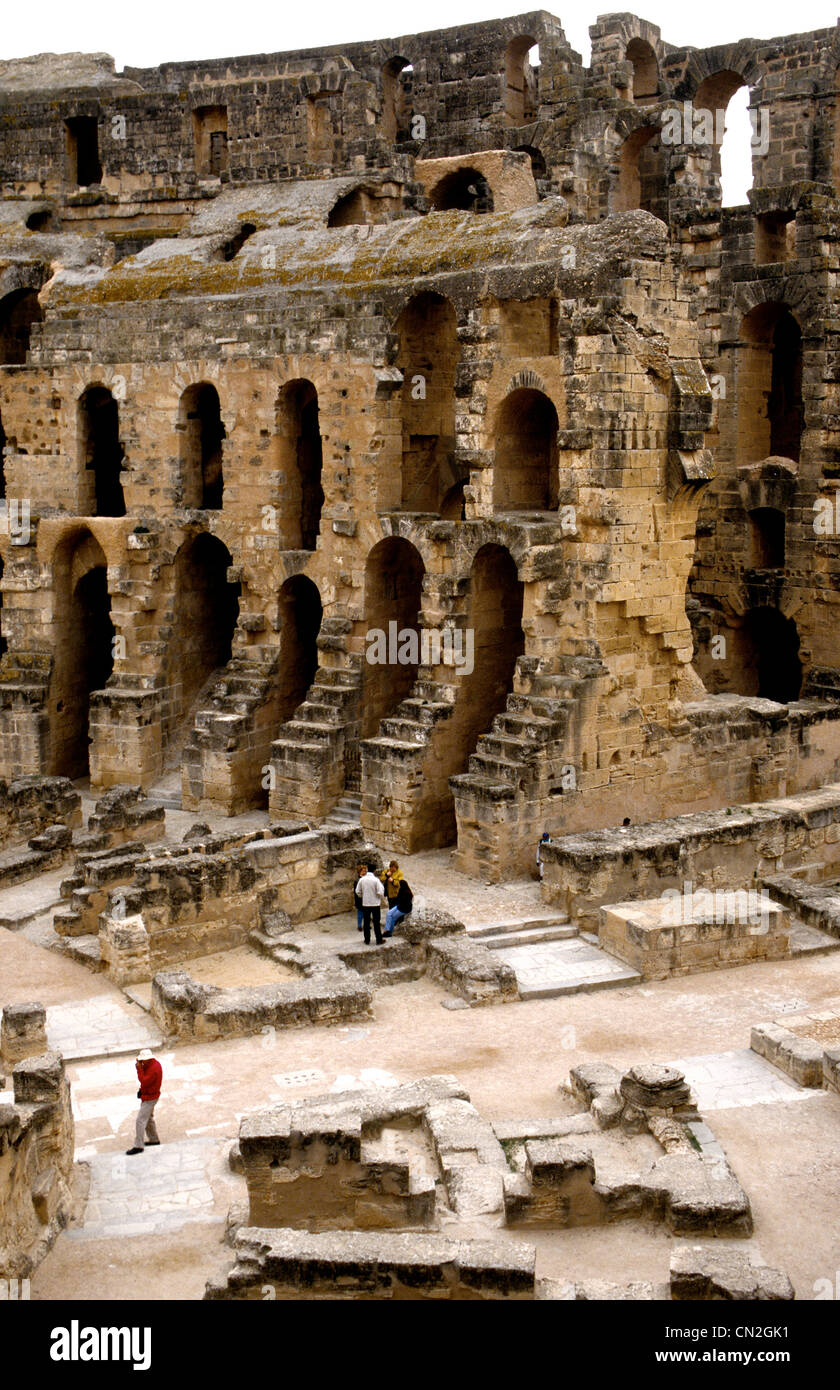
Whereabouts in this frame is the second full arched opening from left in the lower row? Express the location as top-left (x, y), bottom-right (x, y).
top-left (164, 532), bottom-right (241, 737)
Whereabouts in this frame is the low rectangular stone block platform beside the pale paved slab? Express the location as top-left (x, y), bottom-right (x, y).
top-left (598, 891), bottom-right (790, 980)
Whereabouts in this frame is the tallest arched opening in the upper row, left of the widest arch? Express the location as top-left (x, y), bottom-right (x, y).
top-left (396, 293), bottom-right (460, 513)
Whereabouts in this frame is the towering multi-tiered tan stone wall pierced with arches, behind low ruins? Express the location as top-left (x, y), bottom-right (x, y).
top-left (0, 11), bottom-right (840, 878)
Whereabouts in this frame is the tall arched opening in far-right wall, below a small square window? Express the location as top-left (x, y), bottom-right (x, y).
top-left (737, 303), bottom-right (802, 463)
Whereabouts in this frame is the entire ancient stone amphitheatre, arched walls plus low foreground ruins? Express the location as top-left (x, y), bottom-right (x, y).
top-left (0, 11), bottom-right (840, 1298)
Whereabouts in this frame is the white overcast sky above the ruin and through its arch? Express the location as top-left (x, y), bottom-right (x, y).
top-left (0, 0), bottom-right (840, 202)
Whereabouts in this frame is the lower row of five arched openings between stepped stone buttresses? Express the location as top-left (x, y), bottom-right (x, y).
top-left (50, 528), bottom-right (524, 813)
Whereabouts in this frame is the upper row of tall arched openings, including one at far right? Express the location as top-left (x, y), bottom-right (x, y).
top-left (0, 292), bottom-right (804, 525)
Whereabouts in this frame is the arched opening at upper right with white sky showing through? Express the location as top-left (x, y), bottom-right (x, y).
top-left (693, 70), bottom-right (752, 207)
